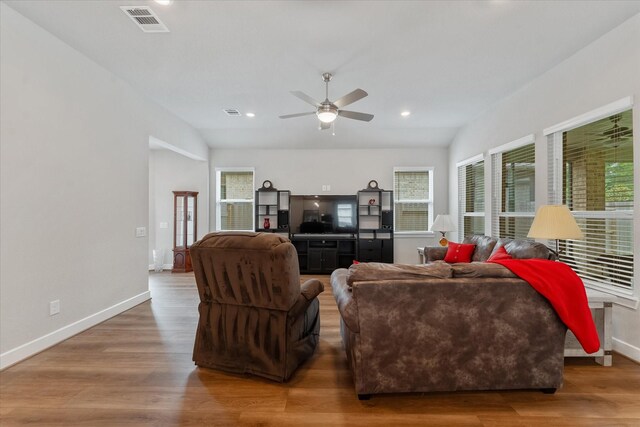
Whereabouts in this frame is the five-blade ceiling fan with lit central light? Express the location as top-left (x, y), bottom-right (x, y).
top-left (280, 73), bottom-right (373, 129)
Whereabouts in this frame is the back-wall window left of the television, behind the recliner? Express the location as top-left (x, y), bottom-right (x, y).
top-left (216, 168), bottom-right (254, 231)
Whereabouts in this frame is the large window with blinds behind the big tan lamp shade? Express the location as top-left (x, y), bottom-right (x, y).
top-left (545, 100), bottom-right (634, 290)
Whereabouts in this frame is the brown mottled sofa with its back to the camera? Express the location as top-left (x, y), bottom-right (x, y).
top-left (331, 239), bottom-right (566, 399)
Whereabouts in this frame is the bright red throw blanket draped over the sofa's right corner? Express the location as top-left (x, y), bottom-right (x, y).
top-left (490, 258), bottom-right (600, 353)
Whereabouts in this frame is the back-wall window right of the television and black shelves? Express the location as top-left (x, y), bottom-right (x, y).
top-left (393, 168), bottom-right (433, 233)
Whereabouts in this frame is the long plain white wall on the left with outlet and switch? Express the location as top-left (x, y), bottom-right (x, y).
top-left (0, 3), bottom-right (208, 368)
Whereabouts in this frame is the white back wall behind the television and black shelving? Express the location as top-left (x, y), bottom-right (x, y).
top-left (209, 149), bottom-right (449, 264)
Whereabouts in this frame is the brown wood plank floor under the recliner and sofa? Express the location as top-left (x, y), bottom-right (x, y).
top-left (0, 273), bottom-right (640, 427)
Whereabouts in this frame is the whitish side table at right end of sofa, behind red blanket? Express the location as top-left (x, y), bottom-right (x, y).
top-left (564, 289), bottom-right (617, 366)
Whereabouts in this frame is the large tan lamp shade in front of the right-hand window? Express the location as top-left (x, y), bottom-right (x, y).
top-left (527, 205), bottom-right (584, 239)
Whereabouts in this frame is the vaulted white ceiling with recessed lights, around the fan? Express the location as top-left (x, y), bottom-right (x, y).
top-left (6, 0), bottom-right (640, 148)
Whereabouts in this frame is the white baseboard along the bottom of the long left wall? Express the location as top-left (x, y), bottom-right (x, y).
top-left (0, 291), bottom-right (151, 371)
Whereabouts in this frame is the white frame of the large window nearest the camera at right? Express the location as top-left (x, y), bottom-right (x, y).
top-left (543, 97), bottom-right (639, 303)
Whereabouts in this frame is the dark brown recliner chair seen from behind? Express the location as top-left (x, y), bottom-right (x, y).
top-left (190, 232), bottom-right (324, 382)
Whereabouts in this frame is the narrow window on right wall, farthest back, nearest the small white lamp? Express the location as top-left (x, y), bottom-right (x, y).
top-left (458, 155), bottom-right (485, 240)
